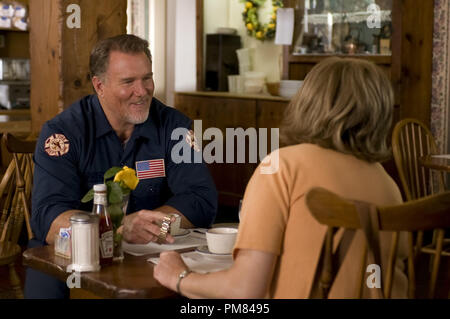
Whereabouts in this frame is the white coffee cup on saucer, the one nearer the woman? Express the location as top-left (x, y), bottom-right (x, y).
top-left (206, 227), bottom-right (238, 254)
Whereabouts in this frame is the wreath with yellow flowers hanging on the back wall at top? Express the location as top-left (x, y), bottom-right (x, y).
top-left (241, 0), bottom-right (283, 41)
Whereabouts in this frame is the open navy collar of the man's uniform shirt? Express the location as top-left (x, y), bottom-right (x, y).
top-left (93, 95), bottom-right (158, 139)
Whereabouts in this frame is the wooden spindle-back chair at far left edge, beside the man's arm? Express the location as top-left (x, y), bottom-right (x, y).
top-left (0, 133), bottom-right (36, 298)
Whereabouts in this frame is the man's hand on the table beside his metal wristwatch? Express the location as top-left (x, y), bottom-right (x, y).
top-left (122, 209), bottom-right (175, 244)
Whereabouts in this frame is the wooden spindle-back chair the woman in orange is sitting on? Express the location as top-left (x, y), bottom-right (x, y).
top-left (306, 188), bottom-right (450, 298)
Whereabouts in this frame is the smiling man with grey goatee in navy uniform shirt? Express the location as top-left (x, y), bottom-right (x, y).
top-left (25, 35), bottom-right (217, 298)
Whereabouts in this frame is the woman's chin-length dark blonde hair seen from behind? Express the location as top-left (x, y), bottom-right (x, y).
top-left (281, 57), bottom-right (394, 162)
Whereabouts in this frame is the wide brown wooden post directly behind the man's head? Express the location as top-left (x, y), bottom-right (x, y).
top-left (30, 0), bottom-right (127, 134)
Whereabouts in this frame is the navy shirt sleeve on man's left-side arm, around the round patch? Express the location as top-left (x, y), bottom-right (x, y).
top-left (31, 124), bottom-right (81, 243)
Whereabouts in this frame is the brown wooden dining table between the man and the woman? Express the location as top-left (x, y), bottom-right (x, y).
top-left (22, 245), bottom-right (185, 299)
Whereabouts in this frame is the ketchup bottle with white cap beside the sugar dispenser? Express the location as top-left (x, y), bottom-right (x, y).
top-left (92, 184), bottom-right (114, 266)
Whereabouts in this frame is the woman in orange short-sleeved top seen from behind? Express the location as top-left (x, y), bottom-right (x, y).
top-left (154, 58), bottom-right (407, 298)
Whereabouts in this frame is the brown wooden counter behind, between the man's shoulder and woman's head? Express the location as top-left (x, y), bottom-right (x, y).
top-left (175, 92), bottom-right (289, 207)
